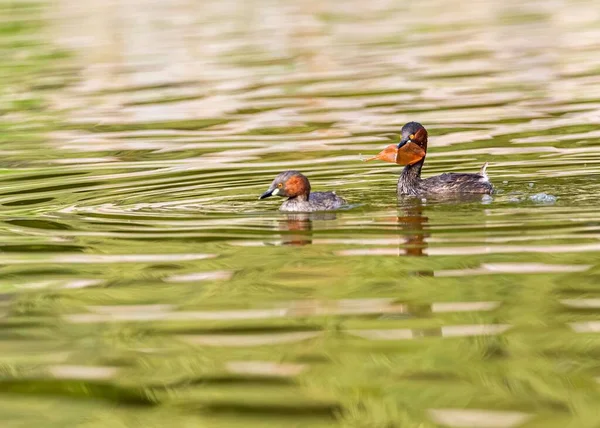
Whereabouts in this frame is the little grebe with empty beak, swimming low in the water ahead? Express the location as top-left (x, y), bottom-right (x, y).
top-left (258, 171), bottom-right (347, 212)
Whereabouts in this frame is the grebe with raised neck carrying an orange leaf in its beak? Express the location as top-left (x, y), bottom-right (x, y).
top-left (367, 122), bottom-right (494, 196)
